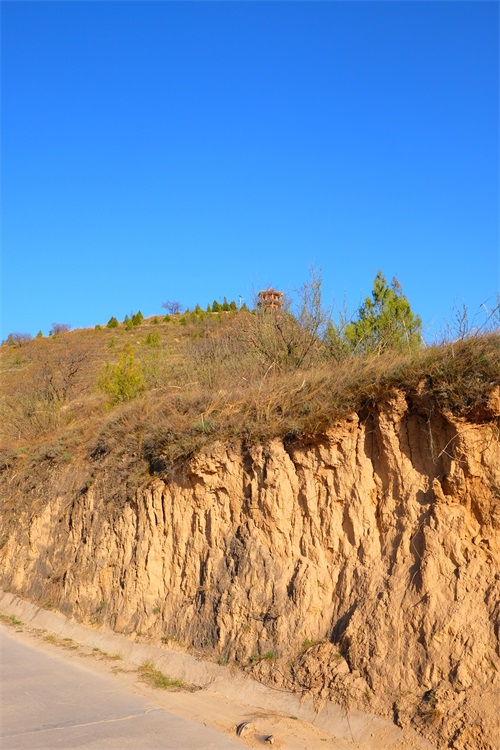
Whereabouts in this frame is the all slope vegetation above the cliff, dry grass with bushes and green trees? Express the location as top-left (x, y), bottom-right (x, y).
top-left (0, 274), bottom-right (500, 488)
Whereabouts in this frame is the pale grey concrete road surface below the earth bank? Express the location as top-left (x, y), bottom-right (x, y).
top-left (0, 626), bottom-right (241, 750)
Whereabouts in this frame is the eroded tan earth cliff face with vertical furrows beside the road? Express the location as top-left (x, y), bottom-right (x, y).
top-left (0, 391), bottom-right (500, 749)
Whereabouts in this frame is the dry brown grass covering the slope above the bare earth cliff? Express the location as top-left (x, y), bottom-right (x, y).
top-left (0, 313), bottom-right (500, 482)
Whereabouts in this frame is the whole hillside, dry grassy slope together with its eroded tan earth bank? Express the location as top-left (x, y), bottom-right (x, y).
top-left (0, 313), bottom-right (500, 750)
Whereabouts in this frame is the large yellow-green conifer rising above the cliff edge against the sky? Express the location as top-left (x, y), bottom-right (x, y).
top-left (344, 271), bottom-right (422, 354)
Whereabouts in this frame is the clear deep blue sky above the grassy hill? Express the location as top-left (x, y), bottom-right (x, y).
top-left (0, 0), bottom-right (500, 338)
